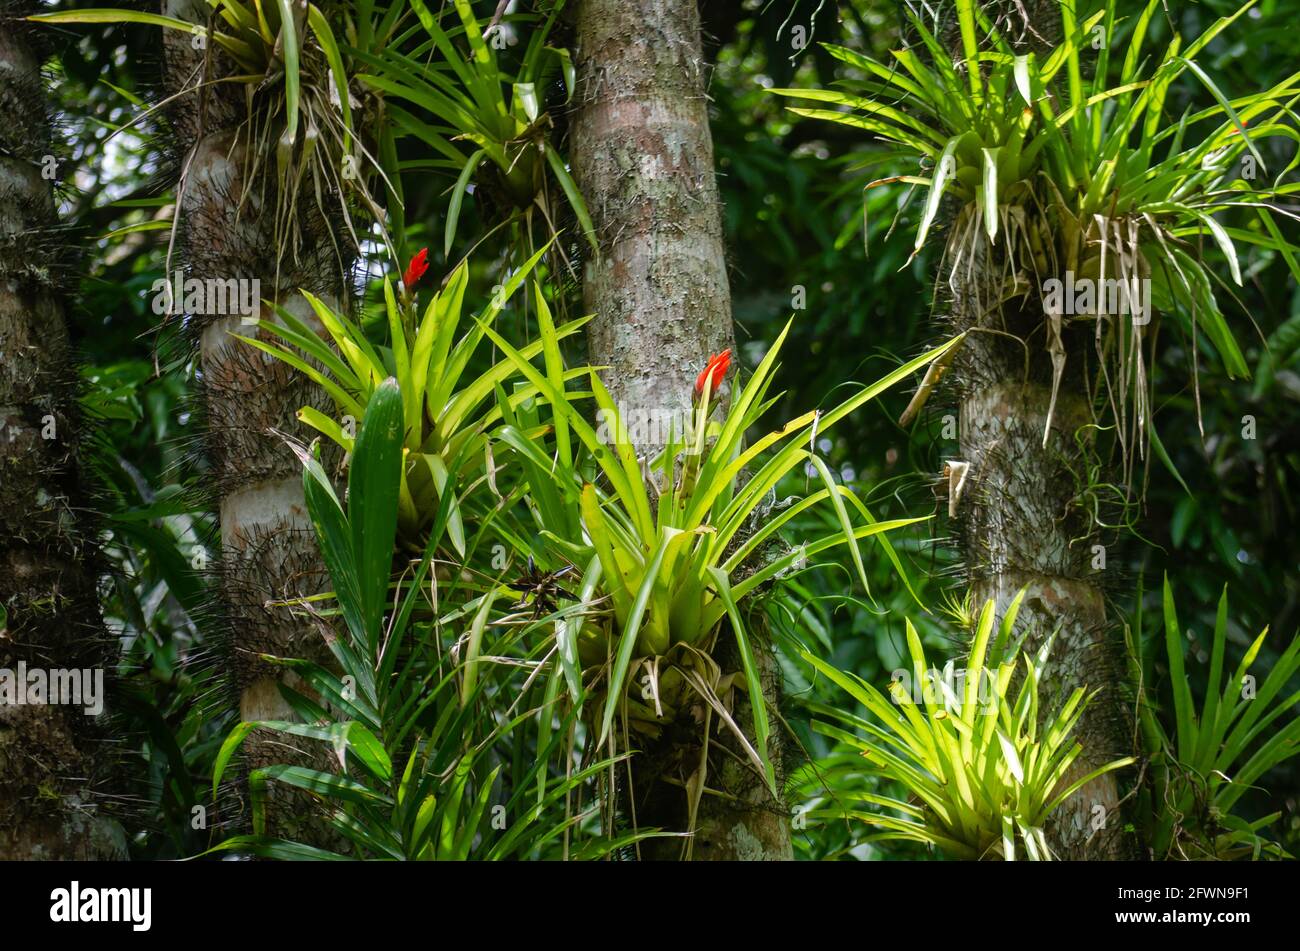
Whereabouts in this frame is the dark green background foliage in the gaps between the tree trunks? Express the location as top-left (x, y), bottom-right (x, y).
top-left (22, 0), bottom-right (1300, 859)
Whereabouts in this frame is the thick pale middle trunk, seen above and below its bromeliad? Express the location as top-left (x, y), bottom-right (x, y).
top-left (572, 0), bottom-right (792, 859)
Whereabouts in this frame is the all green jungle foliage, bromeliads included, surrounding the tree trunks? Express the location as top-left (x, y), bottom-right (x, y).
top-left (0, 0), bottom-right (1300, 860)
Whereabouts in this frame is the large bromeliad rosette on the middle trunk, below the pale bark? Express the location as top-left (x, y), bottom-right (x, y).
top-left (486, 305), bottom-right (959, 783)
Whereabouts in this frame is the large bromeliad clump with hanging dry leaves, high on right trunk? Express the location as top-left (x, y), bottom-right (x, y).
top-left (772, 0), bottom-right (1300, 475)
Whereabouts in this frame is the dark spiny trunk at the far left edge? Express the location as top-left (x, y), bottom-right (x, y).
top-left (0, 12), bottom-right (126, 860)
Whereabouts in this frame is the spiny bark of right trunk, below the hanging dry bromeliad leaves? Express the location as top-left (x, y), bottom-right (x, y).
top-left (954, 323), bottom-right (1132, 859)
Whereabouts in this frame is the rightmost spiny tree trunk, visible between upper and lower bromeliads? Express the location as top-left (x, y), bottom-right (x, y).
top-left (944, 0), bottom-right (1136, 859)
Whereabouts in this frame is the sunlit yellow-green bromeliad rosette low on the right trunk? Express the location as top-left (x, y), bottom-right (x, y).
top-left (805, 592), bottom-right (1134, 861)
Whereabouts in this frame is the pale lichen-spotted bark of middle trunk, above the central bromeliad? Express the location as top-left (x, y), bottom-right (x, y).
top-left (572, 0), bottom-right (735, 442)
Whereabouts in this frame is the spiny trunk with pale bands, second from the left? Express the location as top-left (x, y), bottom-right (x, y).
top-left (164, 0), bottom-right (351, 843)
